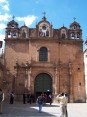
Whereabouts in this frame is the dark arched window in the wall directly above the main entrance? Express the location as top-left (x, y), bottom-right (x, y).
top-left (39, 47), bottom-right (48, 61)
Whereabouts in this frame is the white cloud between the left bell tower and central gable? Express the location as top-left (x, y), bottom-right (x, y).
top-left (16, 15), bottom-right (37, 26)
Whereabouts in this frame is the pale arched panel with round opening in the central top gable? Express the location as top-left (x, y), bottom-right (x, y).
top-left (39, 23), bottom-right (49, 37)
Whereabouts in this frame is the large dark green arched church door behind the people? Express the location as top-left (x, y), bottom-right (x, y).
top-left (34, 73), bottom-right (52, 97)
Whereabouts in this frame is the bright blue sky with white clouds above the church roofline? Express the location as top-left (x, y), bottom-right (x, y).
top-left (0, 0), bottom-right (87, 48)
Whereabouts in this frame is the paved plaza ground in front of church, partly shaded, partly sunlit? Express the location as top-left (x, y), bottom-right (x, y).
top-left (0, 102), bottom-right (87, 117)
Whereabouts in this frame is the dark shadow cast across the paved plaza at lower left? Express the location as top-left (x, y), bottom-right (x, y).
top-left (0, 102), bottom-right (58, 117)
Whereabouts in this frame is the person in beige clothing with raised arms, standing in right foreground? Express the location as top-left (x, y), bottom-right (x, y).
top-left (56, 93), bottom-right (68, 117)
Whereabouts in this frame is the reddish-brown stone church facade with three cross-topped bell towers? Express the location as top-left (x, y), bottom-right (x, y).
top-left (3, 15), bottom-right (86, 102)
